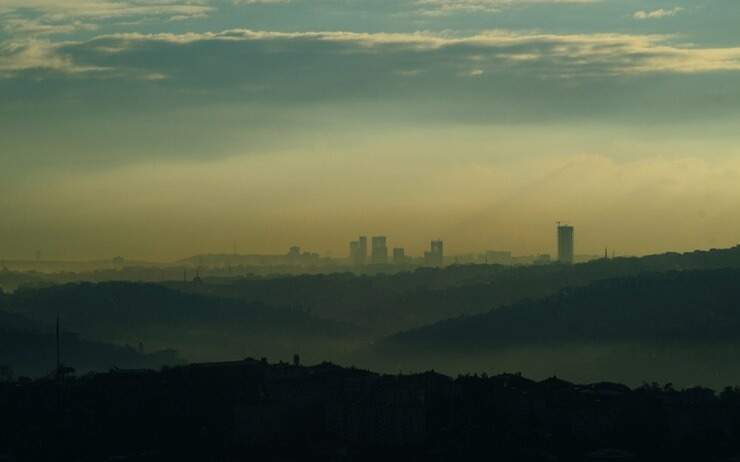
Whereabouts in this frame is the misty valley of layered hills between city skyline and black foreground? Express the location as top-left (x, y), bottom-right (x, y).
top-left (0, 248), bottom-right (740, 389)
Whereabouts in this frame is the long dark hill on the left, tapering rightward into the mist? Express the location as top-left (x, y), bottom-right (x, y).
top-left (2, 282), bottom-right (361, 360)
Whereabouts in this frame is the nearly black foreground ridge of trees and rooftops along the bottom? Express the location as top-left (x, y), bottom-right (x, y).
top-left (0, 360), bottom-right (740, 462)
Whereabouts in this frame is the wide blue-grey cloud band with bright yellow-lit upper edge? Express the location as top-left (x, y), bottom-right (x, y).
top-left (0, 29), bottom-right (740, 128)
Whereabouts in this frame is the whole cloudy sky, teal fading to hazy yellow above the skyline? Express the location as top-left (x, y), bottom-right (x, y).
top-left (0, 0), bottom-right (740, 260)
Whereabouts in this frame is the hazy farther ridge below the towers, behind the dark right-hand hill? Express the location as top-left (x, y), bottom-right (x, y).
top-left (169, 247), bottom-right (740, 335)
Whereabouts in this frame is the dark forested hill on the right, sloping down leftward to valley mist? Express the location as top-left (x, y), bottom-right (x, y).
top-left (385, 269), bottom-right (740, 352)
